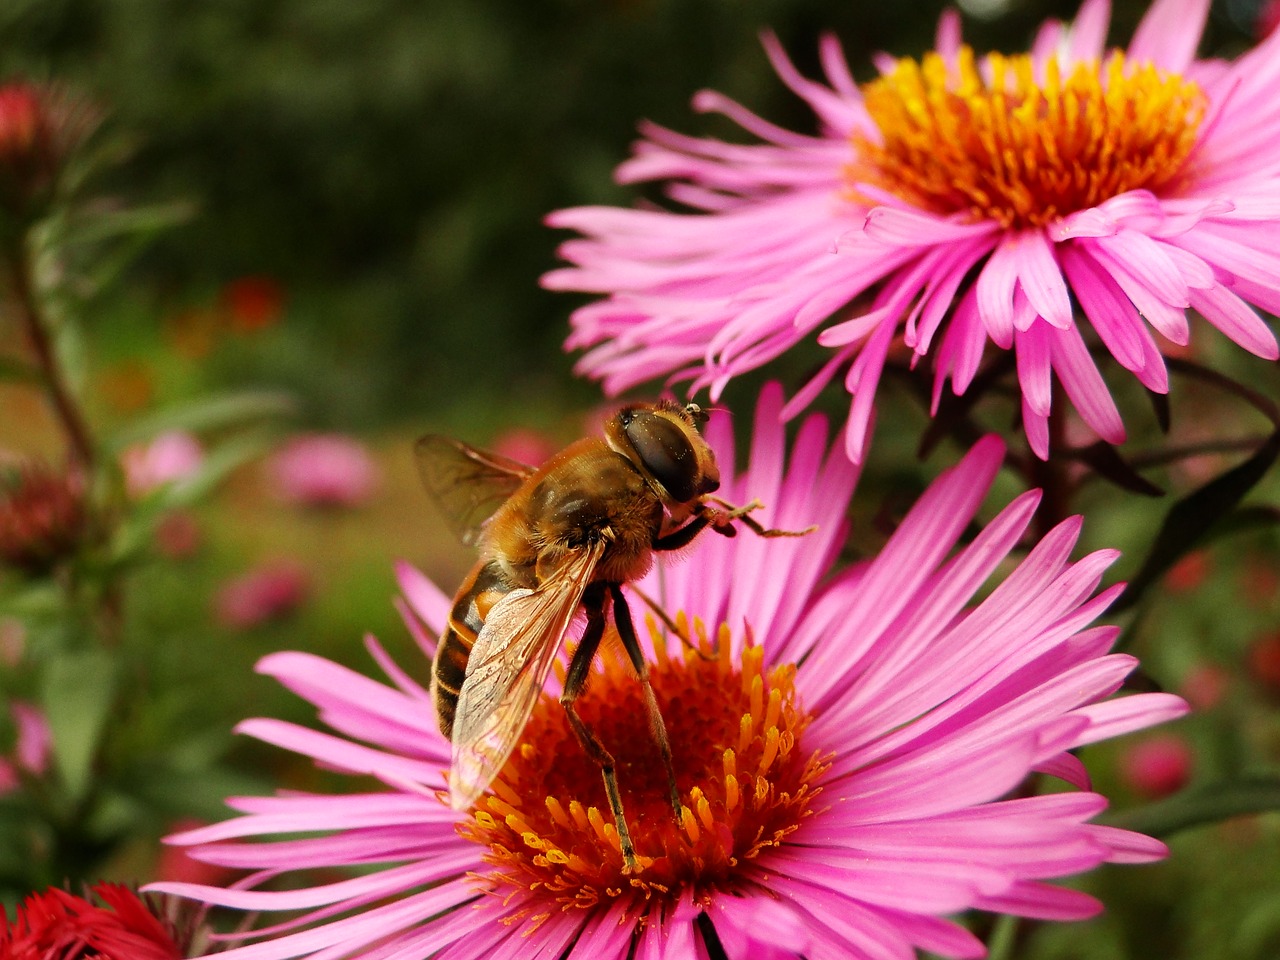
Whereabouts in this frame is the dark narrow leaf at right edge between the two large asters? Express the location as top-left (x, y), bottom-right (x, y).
top-left (1111, 430), bottom-right (1280, 611)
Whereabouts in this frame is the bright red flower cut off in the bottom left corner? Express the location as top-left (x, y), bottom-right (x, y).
top-left (0, 883), bottom-right (183, 960)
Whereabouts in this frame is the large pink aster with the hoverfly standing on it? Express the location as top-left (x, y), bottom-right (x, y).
top-left (155, 388), bottom-right (1185, 960)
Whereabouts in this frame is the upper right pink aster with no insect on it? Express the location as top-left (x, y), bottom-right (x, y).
top-left (544, 0), bottom-right (1280, 460)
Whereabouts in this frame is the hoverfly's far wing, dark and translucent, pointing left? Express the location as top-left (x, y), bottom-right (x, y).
top-left (413, 434), bottom-right (534, 545)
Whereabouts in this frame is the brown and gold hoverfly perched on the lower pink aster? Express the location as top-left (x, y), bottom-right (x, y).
top-left (417, 401), bottom-right (809, 872)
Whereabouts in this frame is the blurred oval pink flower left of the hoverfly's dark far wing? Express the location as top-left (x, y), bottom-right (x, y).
top-left (269, 434), bottom-right (378, 507)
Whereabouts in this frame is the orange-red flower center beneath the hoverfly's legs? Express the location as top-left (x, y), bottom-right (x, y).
top-left (458, 618), bottom-right (826, 915)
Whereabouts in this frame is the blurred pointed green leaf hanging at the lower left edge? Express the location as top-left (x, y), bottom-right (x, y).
top-left (41, 650), bottom-right (116, 799)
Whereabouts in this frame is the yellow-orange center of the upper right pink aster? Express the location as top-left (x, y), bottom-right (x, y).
top-left (845, 47), bottom-right (1207, 229)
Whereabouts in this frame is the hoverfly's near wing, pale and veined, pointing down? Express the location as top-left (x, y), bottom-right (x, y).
top-left (449, 543), bottom-right (605, 810)
